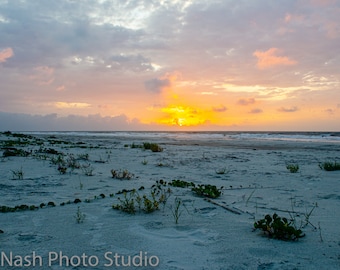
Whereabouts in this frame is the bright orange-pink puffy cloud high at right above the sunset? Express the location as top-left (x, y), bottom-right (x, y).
top-left (253, 48), bottom-right (297, 69)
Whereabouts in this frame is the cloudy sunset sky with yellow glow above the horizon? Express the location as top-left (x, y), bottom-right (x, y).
top-left (0, 0), bottom-right (340, 131)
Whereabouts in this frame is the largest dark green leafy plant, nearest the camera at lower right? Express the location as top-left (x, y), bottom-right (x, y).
top-left (254, 213), bottom-right (305, 241)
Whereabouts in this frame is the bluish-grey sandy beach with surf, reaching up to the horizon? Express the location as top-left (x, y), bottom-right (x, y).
top-left (0, 132), bottom-right (340, 270)
